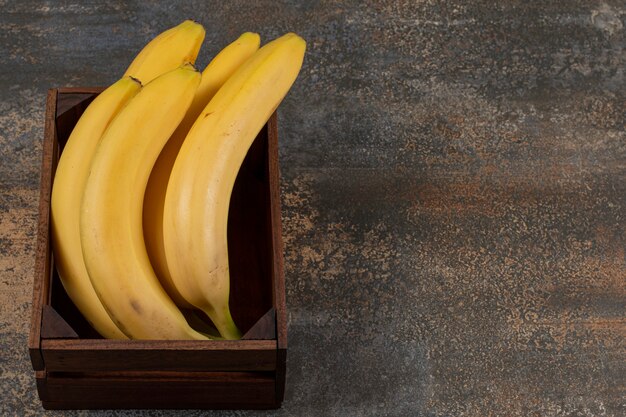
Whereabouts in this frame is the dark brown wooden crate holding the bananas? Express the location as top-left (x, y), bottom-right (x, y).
top-left (29, 88), bottom-right (287, 409)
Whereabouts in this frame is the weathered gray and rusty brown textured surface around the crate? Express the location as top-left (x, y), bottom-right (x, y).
top-left (0, 0), bottom-right (626, 417)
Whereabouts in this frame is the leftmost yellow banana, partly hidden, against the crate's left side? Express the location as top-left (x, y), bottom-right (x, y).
top-left (51, 77), bottom-right (141, 339)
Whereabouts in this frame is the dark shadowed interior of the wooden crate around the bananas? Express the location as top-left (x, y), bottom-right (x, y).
top-left (49, 93), bottom-right (275, 339)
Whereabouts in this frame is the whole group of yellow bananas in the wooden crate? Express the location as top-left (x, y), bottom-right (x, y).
top-left (51, 21), bottom-right (306, 340)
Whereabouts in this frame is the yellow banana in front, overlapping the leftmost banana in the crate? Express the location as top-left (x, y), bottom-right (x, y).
top-left (79, 65), bottom-right (207, 339)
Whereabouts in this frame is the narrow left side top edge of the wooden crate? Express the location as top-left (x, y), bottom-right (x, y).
top-left (28, 90), bottom-right (57, 370)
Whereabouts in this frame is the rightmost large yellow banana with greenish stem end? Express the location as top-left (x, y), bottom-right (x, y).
top-left (163, 33), bottom-right (306, 339)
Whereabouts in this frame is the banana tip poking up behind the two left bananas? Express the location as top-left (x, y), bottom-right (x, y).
top-left (124, 20), bottom-right (205, 85)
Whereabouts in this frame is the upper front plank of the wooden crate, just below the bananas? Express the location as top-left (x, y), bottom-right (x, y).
top-left (41, 339), bottom-right (276, 372)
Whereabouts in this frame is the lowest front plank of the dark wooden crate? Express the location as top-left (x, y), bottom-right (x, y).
top-left (39, 372), bottom-right (275, 409)
